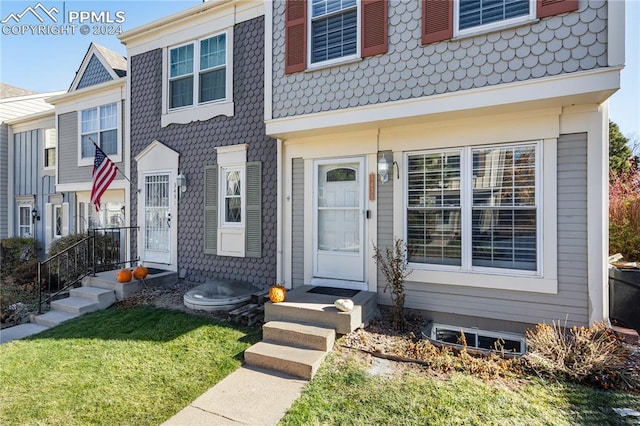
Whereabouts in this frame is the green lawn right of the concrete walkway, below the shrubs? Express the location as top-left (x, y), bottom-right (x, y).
top-left (281, 353), bottom-right (640, 426)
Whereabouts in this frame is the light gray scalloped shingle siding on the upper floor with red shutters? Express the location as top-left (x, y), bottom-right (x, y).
top-left (273, 0), bottom-right (607, 118)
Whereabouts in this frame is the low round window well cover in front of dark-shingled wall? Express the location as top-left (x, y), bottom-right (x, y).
top-left (184, 279), bottom-right (260, 312)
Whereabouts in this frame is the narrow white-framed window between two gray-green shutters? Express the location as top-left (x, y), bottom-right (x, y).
top-left (218, 165), bottom-right (246, 228)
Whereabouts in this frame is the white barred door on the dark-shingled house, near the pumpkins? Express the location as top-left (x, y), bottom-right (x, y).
top-left (142, 173), bottom-right (171, 264)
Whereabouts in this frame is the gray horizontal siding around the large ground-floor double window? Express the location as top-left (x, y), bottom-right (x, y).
top-left (378, 134), bottom-right (589, 325)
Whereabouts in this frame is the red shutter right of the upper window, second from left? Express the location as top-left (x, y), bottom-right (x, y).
top-left (360, 0), bottom-right (389, 58)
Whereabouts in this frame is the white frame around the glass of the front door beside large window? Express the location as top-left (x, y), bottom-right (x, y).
top-left (310, 156), bottom-right (368, 290)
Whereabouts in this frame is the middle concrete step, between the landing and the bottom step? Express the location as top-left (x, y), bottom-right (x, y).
top-left (262, 321), bottom-right (336, 352)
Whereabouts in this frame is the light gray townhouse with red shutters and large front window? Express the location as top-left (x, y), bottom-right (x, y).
top-left (265, 0), bottom-right (624, 336)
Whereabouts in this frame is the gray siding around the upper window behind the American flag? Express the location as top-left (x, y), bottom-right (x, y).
top-left (57, 102), bottom-right (125, 184)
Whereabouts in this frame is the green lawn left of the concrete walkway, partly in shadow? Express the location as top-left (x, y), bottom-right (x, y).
top-left (0, 307), bottom-right (261, 425)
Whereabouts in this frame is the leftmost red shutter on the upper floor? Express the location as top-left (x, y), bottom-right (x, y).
top-left (284, 0), bottom-right (307, 74)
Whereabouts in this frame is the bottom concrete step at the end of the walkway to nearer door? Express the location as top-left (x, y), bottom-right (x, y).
top-left (244, 342), bottom-right (327, 380)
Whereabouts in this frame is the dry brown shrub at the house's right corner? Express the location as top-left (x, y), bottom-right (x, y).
top-left (524, 321), bottom-right (639, 389)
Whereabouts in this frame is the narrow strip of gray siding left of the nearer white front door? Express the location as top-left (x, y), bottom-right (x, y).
top-left (291, 158), bottom-right (305, 287)
